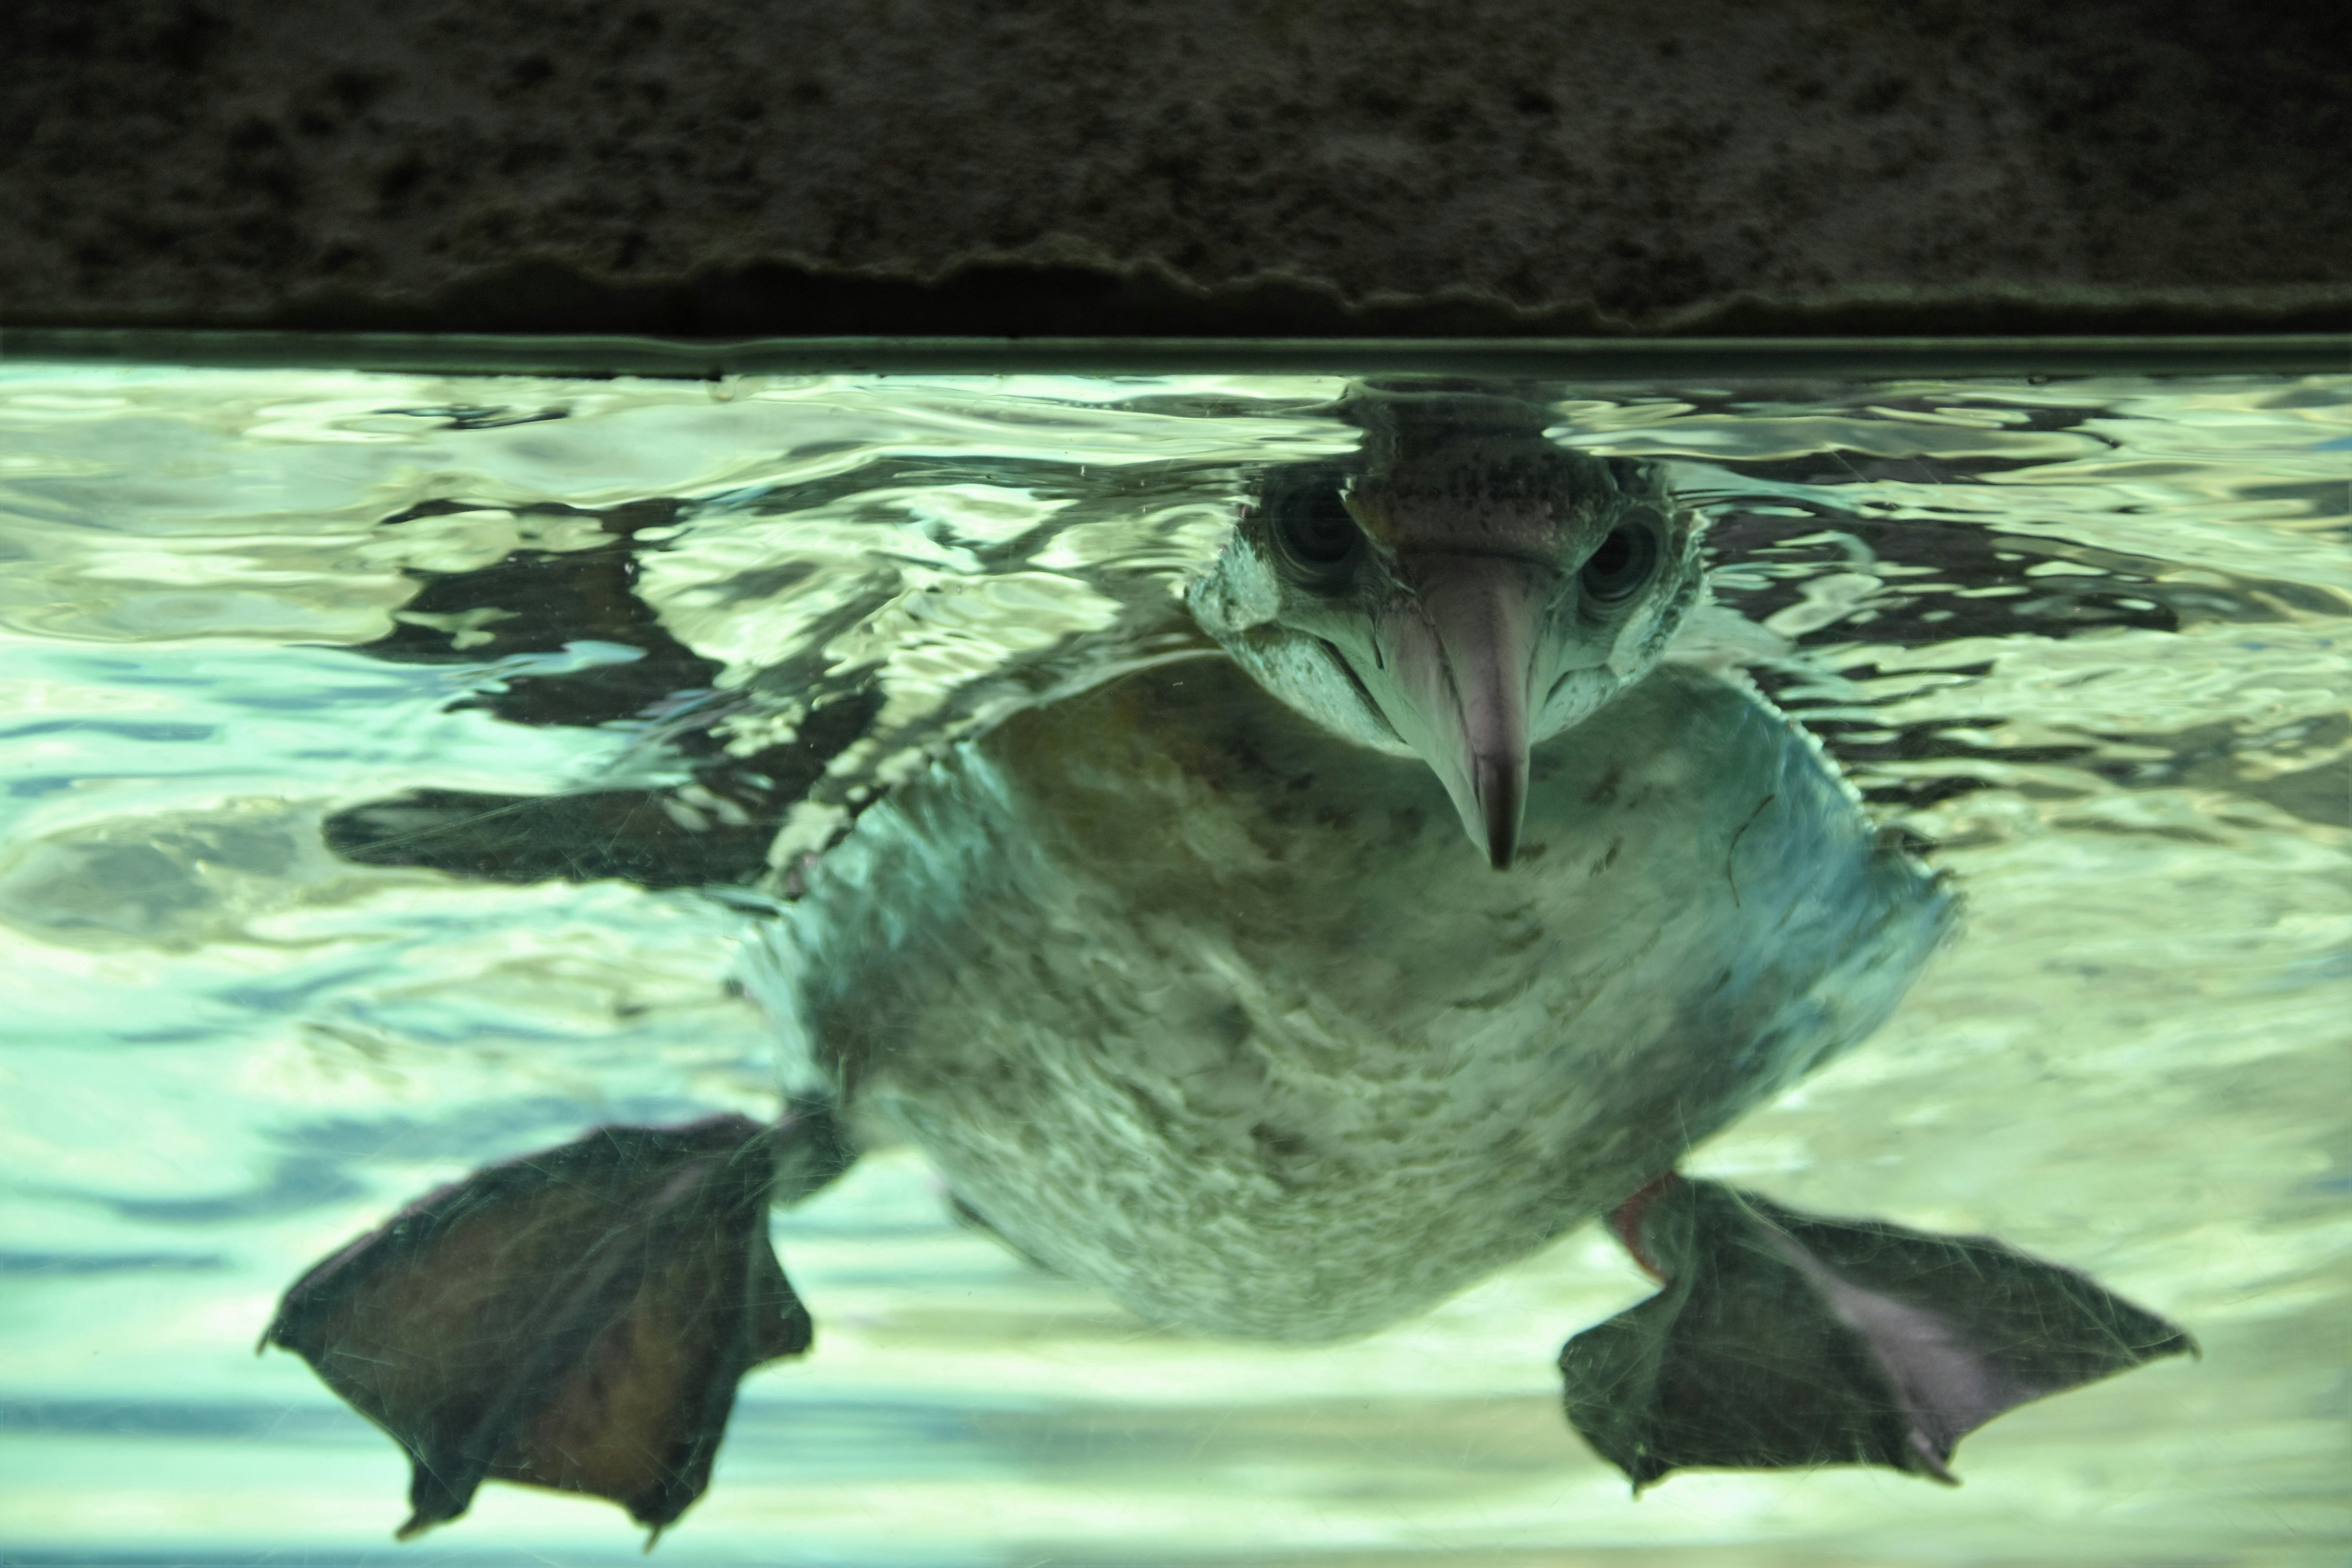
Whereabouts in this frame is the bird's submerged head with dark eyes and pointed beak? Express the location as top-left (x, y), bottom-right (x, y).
top-left (1188, 390), bottom-right (1703, 870)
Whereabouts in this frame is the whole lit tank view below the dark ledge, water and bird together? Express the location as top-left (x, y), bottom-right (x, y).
top-left (0, 360), bottom-right (2352, 1568)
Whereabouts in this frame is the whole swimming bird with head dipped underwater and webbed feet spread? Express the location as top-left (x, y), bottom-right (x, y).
top-left (268, 388), bottom-right (2190, 1533)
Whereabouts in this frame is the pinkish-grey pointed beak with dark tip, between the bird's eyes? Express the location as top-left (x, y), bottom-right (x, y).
top-left (1376, 552), bottom-right (1555, 870)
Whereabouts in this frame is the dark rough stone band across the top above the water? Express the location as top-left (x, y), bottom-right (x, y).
top-left (0, 0), bottom-right (2352, 332)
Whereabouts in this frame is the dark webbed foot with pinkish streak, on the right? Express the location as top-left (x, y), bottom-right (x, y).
top-left (1559, 1176), bottom-right (2197, 1490)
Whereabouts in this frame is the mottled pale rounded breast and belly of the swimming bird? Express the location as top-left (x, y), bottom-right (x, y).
top-left (750, 658), bottom-right (1950, 1340)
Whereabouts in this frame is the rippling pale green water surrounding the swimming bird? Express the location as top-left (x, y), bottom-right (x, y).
top-left (0, 365), bottom-right (2352, 1563)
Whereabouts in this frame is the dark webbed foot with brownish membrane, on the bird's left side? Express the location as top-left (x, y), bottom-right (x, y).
top-left (261, 1110), bottom-right (847, 1547)
